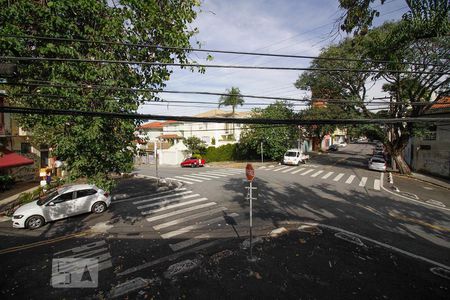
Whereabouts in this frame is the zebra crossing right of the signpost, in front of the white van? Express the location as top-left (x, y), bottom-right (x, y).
top-left (258, 165), bottom-right (381, 191)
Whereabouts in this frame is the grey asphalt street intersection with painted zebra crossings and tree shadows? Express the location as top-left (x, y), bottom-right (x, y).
top-left (0, 144), bottom-right (450, 299)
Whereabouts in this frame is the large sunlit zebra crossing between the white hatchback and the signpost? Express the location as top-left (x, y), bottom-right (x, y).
top-left (132, 189), bottom-right (239, 252)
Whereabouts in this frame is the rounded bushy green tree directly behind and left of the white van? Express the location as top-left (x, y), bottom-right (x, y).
top-left (237, 101), bottom-right (298, 160)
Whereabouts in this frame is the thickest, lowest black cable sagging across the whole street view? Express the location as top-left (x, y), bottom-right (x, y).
top-left (0, 106), bottom-right (450, 125)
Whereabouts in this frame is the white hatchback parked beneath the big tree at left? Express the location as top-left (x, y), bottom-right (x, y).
top-left (12, 184), bottom-right (111, 229)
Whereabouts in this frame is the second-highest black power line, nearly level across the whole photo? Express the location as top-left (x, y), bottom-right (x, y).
top-left (0, 56), bottom-right (449, 75)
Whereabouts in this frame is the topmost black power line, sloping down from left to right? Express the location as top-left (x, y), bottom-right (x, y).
top-left (0, 34), bottom-right (442, 66)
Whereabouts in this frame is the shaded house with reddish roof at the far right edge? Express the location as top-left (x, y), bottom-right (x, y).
top-left (404, 96), bottom-right (450, 178)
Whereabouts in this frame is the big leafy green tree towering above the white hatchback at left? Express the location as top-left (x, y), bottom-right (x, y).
top-left (0, 0), bottom-right (197, 189)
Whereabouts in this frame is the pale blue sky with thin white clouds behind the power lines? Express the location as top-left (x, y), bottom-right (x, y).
top-left (139, 0), bottom-right (407, 116)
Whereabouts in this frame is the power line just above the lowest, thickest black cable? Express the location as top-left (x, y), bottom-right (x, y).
top-left (0, 81), bottom-right (431, 106)
